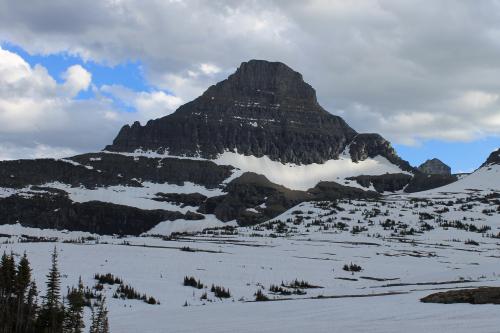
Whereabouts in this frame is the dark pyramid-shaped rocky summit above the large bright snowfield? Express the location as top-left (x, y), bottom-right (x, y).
top-left (106, 60), bottom-right (402, 165)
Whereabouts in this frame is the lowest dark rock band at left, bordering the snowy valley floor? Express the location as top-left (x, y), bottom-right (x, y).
top-left (0, 193), bottom-right (204, 235)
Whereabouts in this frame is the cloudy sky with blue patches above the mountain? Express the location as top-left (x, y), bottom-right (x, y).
top-left (0, 0), bottom-right (500, 172)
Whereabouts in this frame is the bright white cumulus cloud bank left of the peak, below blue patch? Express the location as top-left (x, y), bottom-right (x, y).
top-left (0, 48), bottom-right (181, 160)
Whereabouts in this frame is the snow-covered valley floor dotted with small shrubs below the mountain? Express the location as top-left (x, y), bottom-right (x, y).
top-left (0, 193), bottom-right (500, 332)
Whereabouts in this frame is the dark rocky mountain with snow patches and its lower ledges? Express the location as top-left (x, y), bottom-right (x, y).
top-left (0, 60), bottom-right (456, 235)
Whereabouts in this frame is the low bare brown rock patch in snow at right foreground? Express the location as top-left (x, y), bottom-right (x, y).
top-left (420, 287), bottom-right (500, 304)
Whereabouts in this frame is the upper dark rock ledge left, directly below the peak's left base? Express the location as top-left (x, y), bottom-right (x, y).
top-left (0, 153), bottom-right (233, 188)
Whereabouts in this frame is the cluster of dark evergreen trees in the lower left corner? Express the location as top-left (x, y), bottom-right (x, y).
top-left (0, 247), bottom-right (109, 333)
